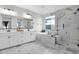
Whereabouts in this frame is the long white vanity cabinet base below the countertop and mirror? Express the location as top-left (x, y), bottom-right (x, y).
top-left (0, 32), bottom-right (35, 49)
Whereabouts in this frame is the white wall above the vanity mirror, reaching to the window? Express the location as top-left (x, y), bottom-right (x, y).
top-left (0, 5), bottom-right (42, 32)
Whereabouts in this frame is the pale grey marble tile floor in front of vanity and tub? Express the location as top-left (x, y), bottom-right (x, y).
top-left (0, 41), bottom-right (73, 54)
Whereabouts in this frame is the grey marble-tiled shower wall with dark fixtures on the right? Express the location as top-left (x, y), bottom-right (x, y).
top-left (55, 6), bottom-right (79, 45)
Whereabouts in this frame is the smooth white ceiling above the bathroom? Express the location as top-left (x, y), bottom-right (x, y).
top-left (16, 5), bottom-right (69, 15)
